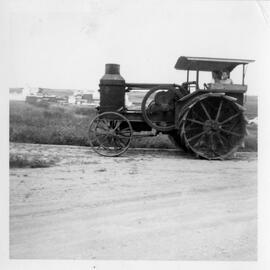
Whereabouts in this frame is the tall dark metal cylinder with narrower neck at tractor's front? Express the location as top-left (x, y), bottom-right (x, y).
top-left (99, 64), bottom-right (125, 112)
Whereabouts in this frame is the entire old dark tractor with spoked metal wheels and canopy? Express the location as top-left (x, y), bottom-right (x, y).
top-left (89, 56), bottom-right (254, 160)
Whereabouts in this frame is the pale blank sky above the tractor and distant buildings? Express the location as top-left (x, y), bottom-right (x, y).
top-left (8, 0), bottom-right (270, 95)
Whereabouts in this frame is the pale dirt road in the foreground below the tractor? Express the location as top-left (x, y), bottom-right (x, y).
top-left (10, 144), bottom-right (257, 260)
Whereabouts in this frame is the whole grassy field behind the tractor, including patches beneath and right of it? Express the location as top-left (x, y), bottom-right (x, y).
top-left (9, 96), bottom-right (257, 151)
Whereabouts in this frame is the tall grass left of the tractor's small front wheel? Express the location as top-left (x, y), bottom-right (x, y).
top-left (10, 101), bottom-right (95, 145)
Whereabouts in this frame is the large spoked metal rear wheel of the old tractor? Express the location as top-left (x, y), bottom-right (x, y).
top-left (180, 95), bottom-right (246, 159)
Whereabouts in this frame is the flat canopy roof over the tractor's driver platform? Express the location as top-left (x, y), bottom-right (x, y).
top-left (175, 56), bottom-right (254, 72)
